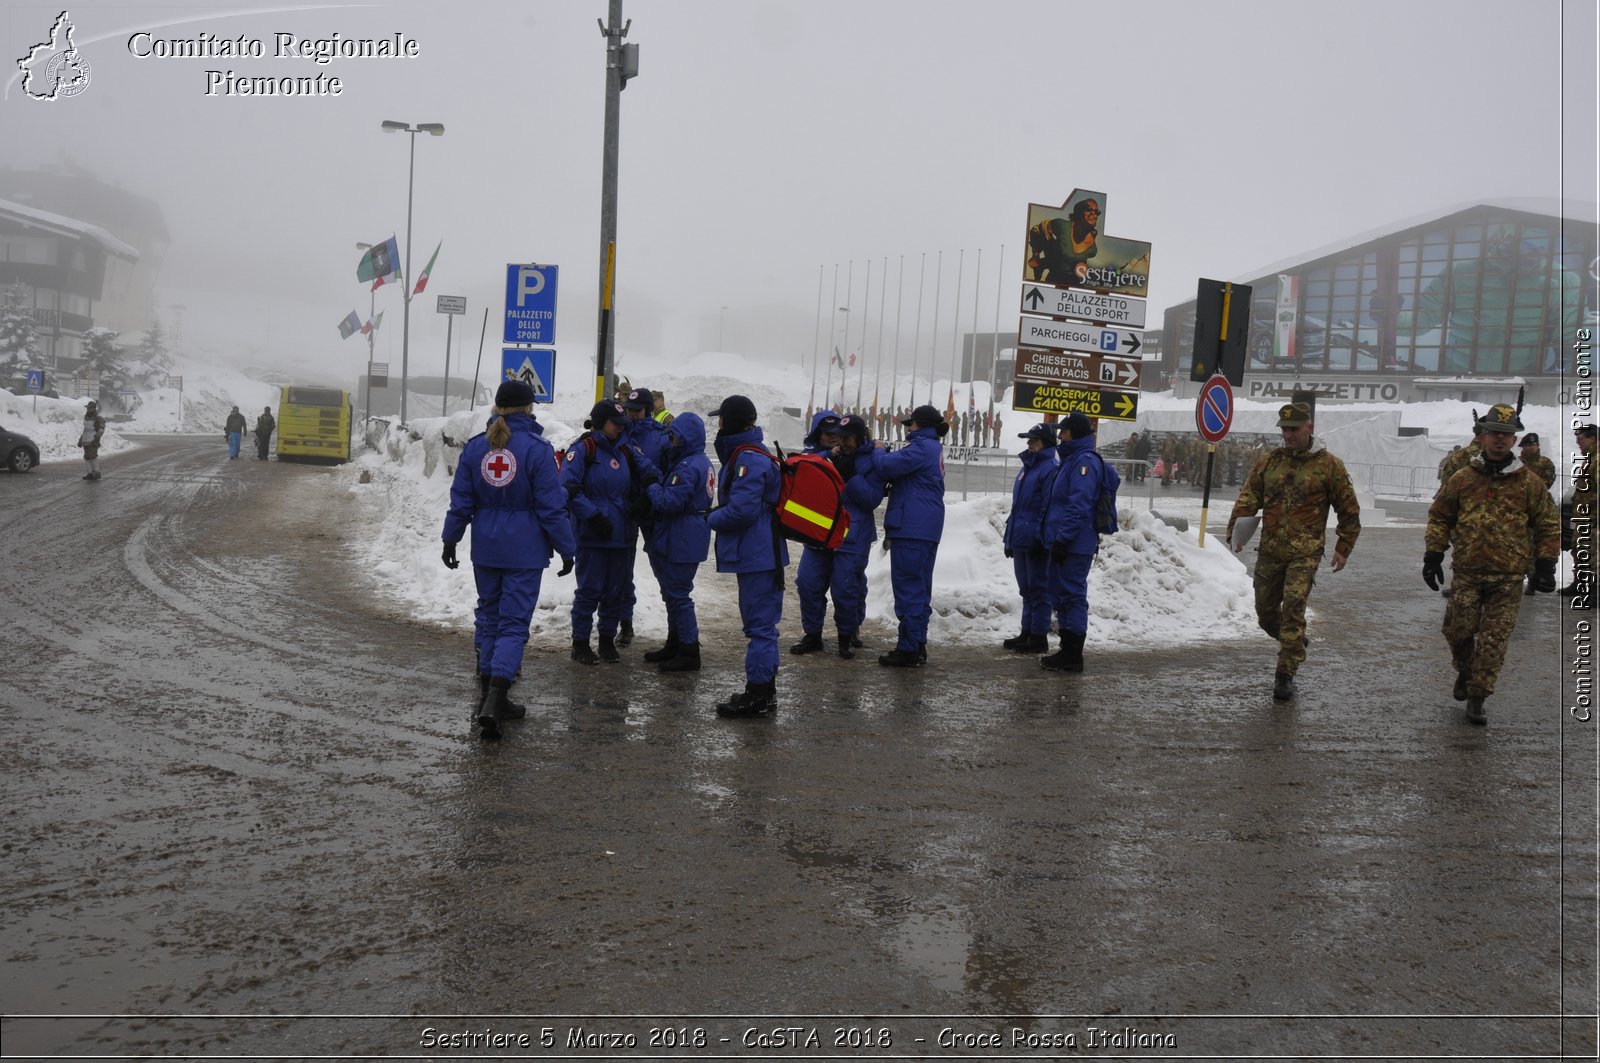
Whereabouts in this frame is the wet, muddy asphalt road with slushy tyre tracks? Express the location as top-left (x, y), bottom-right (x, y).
top-left (0, 439), bottom-right (1597, 1058)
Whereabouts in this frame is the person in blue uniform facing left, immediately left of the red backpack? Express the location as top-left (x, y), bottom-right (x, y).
top-left (709, 395), bottom-right (789, 717)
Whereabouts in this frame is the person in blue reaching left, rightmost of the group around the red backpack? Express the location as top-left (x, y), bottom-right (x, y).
top-left (872, 407), bottom-right (950, 668)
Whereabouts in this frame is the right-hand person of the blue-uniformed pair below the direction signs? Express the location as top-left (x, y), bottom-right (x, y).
top-left (1040, 413), bottom-right (1102, 672)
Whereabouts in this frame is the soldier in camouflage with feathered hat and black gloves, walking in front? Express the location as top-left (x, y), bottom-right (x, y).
top-left (1422, 405), bottom-right (1562, 724)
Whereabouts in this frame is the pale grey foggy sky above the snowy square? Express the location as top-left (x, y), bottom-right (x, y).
top-left (0, 0), bottom-right (1597, 387)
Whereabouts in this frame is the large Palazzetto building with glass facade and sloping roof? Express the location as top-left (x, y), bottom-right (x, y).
top-left (1163, 200), bottom-right (1600, 402)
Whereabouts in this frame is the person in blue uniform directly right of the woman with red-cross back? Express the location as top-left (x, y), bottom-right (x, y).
top-left (562, 402), bottom-right (661, 664)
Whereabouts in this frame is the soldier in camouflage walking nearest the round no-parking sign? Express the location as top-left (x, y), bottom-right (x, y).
top-left (1227, 402), bottom-right (1362, 701)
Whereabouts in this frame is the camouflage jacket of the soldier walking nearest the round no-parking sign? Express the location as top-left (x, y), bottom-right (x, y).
top-left (1227, 445), bottom-right (1362, 559)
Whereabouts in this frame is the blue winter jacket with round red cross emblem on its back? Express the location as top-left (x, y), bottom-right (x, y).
top-left (440, 413), bottom-right (578, 568)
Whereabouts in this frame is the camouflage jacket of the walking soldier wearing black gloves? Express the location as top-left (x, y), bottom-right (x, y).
top-left (1426, 456), bottom-right (1562, 576)
